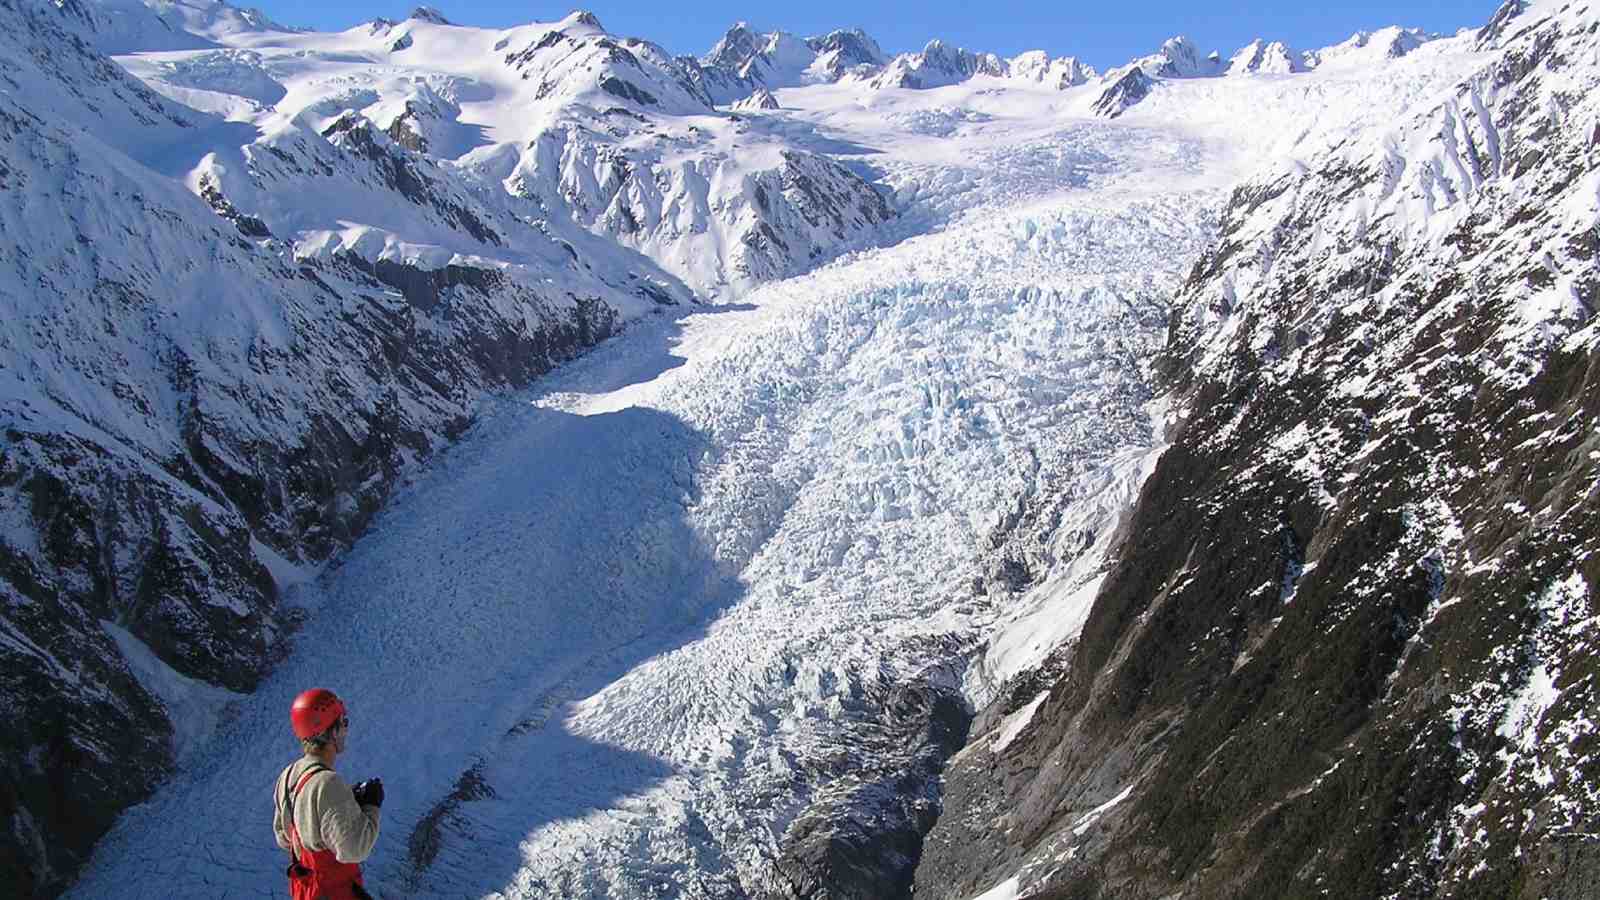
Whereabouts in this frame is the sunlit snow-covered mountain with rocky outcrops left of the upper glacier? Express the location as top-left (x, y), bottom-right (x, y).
top-left (103, 3), bottom-right (891, 299)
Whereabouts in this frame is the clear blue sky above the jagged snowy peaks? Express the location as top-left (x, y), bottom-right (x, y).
top-left (246, 0), bottom-right (1498, 69)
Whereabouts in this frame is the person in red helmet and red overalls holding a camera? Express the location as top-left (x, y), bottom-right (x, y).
top-left (272, 687), bottom-right (384, 900)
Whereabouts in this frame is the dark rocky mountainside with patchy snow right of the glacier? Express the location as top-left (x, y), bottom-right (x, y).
top-left (915, 0), bottom-right (1600, 900)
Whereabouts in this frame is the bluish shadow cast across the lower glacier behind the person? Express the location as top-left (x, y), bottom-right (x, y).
top-left (67, 304), bottom-right (742, 897)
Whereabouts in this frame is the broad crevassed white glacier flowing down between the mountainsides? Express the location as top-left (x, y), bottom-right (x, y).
top-left (56, 12), bottom-right (1504, 897)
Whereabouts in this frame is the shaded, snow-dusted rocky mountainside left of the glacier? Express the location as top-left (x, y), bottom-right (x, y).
top-left (0, 0), bottom-right (659, 897)
